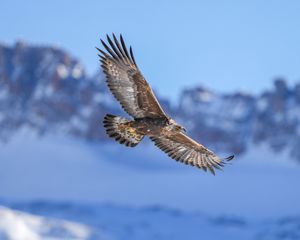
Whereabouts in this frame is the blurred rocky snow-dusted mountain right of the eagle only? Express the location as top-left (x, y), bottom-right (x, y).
top-left (179, 79), bottom-right (300, 160)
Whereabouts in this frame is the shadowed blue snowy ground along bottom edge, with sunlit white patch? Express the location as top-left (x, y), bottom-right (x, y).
top-left (0, 201), bottom-right (300, 240)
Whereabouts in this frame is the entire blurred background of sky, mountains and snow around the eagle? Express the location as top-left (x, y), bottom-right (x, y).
top-left (0, 0), bottom-right (300, 240)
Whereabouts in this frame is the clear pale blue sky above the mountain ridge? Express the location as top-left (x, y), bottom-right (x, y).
top-left (0, 0), bottom-right (300, 99)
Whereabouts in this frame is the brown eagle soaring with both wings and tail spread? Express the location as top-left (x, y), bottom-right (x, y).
top-left (96, 33), bottom-right (234, 175)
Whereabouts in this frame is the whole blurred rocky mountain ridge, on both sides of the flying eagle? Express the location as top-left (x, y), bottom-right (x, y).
top-left (0, 42), bottom-right (300, 160)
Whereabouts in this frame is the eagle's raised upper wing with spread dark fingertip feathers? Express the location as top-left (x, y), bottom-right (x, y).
top-left (97, 34), bottom-right (167, 118)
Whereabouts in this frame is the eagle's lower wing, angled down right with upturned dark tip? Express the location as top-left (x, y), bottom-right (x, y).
top-left (150, 132), bottom-right (234, 174)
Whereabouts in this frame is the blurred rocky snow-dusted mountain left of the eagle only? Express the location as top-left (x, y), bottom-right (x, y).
top-left (0, 42), bottom-right (112, 141)
